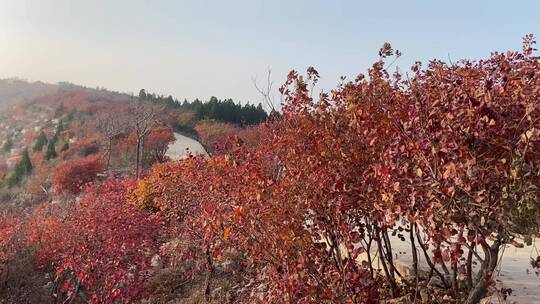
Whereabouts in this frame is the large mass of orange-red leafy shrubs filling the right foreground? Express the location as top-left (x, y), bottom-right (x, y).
top-left (132, 38), bottom-right (540, 303)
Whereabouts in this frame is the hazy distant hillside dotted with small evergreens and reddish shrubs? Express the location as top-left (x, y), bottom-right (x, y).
top-left (0, 80), bottom-right (266, 205)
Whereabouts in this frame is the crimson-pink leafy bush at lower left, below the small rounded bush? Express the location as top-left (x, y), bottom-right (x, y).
top-left (32, 180), bottom-right (159, 303)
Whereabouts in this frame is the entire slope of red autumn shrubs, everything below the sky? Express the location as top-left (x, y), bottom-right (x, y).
top-left (0, 41), bottom-right (540, 304)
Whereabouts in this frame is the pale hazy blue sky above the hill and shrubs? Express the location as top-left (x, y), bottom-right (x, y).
top-left (0, 0), bottom-right (540, 102)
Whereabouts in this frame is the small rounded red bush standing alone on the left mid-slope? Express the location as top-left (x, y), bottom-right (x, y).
top-left (53, 155), bottom-right (104, 194)
